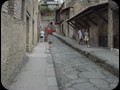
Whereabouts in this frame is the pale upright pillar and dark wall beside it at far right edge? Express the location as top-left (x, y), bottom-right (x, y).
top-left (108, 0), bottom-right (119, 50)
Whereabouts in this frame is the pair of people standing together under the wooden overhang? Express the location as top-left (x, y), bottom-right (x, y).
top-left (78, 29), bottom-right (89, 47)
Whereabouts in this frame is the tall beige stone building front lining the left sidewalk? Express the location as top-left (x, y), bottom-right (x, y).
top-left (1, 0), bottom-right (39, 88)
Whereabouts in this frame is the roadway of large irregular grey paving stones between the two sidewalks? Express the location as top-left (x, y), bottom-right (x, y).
top-left (49, 36), bottom-right (119, 90)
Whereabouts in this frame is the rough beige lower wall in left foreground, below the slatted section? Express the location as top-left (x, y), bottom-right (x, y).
top-left (1, 12), bottom-right (26, 88)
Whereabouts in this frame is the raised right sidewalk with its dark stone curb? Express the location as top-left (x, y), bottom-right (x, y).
top-left (54, 33), bottom-right (119, 77)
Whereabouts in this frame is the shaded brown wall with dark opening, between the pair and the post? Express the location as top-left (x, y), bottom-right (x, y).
top-left (89, 10), bottom-right (108, 47)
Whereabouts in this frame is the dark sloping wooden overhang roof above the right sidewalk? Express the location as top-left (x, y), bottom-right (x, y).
top-left (67, 2), bottom-right (109, 29)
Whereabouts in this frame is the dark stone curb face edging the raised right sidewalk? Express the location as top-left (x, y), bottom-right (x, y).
top-left (53, 34), bottom-right (119, 77)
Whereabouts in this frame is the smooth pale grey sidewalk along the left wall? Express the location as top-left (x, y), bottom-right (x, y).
top-left (9, 42), bottom-right (58, 90)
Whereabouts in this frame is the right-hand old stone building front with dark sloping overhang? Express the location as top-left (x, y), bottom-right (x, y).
top-left (55, 0), bottom-right (119, 49)
